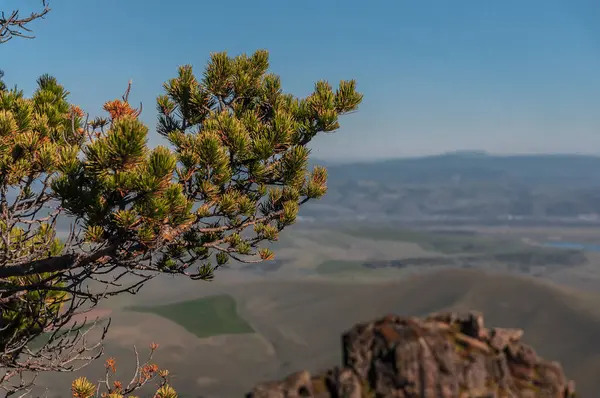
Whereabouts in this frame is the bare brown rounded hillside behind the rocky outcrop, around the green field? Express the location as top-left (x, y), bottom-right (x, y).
top-left (35, 269), bottom-right (600, 397)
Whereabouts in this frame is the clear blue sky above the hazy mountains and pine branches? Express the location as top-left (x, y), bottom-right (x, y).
top-left (0, 0), bottom-right (600, 160)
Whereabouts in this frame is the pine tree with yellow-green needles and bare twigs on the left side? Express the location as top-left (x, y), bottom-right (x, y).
top-left (0, 50), bottom-right (362, 391)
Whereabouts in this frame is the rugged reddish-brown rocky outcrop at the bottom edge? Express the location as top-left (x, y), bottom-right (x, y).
top-left (247, 313), bottom-right (575, 398)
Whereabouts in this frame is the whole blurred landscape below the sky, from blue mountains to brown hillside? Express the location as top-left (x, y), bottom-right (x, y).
top-left (32, 154), bottom-right (600, 397)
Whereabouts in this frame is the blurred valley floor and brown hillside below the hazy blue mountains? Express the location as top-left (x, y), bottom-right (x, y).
top-left (34, 225), bottom-right (600, 397)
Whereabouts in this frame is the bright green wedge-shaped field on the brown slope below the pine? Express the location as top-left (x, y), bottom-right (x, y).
top-left (127, 294), bottom-right (254, 338)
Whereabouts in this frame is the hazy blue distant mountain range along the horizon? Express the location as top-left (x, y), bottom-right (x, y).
top-left (301, 152), bottom-right (600, 221)
